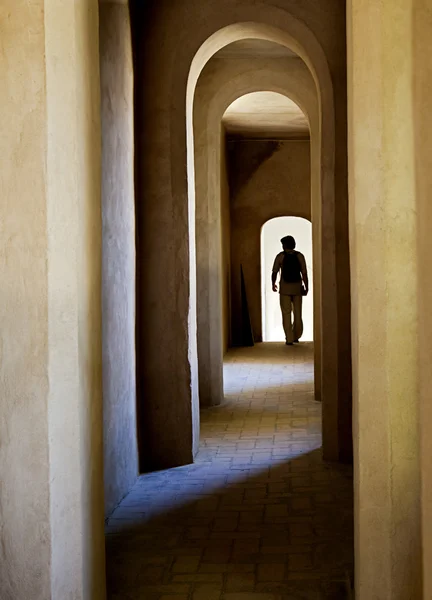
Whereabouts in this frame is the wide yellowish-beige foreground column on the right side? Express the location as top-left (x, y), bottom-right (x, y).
top-left (348, 0), bottom-right (422, 600)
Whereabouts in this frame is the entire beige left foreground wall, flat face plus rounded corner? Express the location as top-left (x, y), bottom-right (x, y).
top-left (0, 0), bottom-right (105, 600)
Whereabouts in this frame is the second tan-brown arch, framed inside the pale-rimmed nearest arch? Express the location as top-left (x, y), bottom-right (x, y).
top-left (193, 60), bottom-right (320, 406)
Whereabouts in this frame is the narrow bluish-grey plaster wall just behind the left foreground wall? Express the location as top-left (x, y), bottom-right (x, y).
top-left (99, 3), bottom-right (138, 515)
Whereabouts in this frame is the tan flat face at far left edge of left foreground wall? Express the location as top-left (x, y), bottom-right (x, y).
top-left (0, 0), bottom-right (51, 600)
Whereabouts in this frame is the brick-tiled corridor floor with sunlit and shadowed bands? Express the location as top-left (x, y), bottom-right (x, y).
top-left (107, 344), bottom-right (353, 600)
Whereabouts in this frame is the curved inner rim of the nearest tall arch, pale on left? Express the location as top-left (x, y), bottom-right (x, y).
top-left (182, 22), bottom-right (340, 459)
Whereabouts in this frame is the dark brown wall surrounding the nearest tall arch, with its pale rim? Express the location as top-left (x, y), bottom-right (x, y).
top-left (134, 0), bottom-right (350, 466)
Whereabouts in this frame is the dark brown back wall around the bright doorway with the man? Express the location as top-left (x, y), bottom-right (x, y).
top-left (228, 141), bottom-right (311, 344)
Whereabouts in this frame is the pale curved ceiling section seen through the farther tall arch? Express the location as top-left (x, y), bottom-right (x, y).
top-left (222, 92), bottom-right (309, 140)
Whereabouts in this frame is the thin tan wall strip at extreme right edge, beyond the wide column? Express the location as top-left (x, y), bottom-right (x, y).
top-left (412, 0), bottom-right (432, 598)
